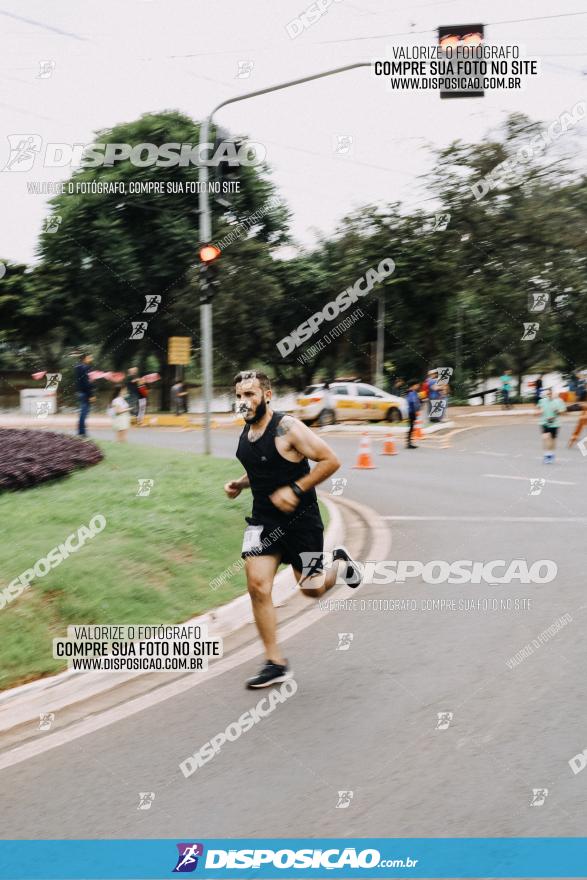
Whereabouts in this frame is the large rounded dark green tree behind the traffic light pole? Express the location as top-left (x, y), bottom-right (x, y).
top-left (39, 112), bottom-right (287, 402)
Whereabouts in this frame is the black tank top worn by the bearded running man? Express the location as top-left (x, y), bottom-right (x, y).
top-left (236, 412), bottom-right (321, 524)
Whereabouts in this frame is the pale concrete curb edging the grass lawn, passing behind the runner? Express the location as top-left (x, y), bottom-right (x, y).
top-left (0, 493), bottom-right (344, 734)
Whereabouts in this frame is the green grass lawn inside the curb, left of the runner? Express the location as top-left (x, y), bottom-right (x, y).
top-left (0, 443), bottom-right (325, 689)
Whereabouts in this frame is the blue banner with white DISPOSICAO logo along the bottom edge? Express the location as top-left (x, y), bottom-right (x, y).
top-left (0, 837), bottom-right (587, 880)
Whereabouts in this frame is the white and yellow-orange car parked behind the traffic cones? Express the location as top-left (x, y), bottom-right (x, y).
top-left (295, 382), bottom-right (408, 425)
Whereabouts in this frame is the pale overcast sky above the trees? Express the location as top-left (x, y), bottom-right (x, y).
top-left (0, 0), bottom-right (587, 261)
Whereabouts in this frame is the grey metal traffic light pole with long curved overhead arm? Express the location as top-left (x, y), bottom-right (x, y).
top-left (199, 61), bottom-right (371, 455)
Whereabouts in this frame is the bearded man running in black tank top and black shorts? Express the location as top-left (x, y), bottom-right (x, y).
top-left (224, 371), bottom-right (361, 688)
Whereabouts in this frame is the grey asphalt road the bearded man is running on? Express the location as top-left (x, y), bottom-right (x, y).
top-left (0, 419), bottom-right (587, 840)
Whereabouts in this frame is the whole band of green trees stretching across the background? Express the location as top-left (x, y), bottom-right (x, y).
top-left (0, 111), bottom-right (587, 395)
